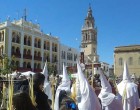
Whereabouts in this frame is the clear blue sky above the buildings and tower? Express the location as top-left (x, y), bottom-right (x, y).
top-left (0, 0), bottom-right (140, 64)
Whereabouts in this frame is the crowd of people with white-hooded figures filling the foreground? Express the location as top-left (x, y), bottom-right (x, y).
top-left (0, 61), bottom-right (140, 110)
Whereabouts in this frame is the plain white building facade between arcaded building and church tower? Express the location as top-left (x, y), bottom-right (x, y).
top-left (60, 44), bottom-right (79, 73)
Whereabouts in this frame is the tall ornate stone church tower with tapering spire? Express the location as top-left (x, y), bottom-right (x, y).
top-left (81, 6), bottom-right (98, 62)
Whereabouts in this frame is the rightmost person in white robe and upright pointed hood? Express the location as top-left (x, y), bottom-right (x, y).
top-left (117, 62), bottom-right (140, 110)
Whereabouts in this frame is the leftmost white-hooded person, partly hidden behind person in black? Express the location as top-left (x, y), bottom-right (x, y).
top-left (42, 60), bottom-right (52, 100)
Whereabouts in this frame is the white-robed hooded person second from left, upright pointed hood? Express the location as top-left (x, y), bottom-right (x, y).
top-left (54, 64), bottom-right (71, 110)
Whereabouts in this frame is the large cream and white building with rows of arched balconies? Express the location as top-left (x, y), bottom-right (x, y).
top-left (0, 19), bottom-right (59, 72)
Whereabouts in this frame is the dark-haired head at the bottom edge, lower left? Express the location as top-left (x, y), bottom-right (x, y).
top-left (13, 92), bottom-right (37, 110)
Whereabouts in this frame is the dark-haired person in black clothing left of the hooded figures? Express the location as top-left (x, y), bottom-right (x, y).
top-left (33, 73), bottom-right (51, 110)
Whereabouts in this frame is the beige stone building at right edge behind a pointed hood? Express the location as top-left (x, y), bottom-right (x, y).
top-left (114, 45), bottom-right (140, 76)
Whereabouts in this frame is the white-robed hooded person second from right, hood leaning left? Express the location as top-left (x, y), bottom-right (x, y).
top-left (98, 69), bottom-right (123, 110)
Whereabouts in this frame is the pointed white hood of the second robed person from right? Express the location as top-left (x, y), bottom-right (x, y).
top-left (99, 68), bottom-right (112, 93)
